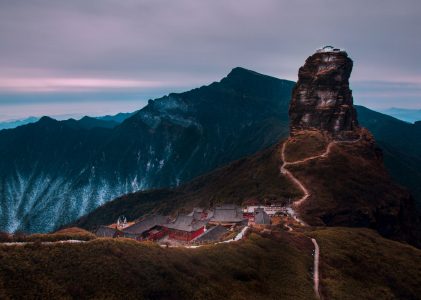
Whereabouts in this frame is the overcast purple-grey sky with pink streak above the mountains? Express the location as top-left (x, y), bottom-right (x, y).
top-left (0, 0), bottom-right (421, 121)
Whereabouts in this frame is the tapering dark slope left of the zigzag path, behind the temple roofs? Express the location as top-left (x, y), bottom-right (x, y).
top-left (75, 145), bottom-right (300, 229)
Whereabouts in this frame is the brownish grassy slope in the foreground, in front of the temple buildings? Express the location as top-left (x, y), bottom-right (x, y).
top-left (0, 227), bottom-right (421, 300)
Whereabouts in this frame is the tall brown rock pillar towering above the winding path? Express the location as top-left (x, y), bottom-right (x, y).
top-left (289, 47), bottom-right (358, 139)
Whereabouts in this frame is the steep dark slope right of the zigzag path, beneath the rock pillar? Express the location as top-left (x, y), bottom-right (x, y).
top-left (286, 130), bottom-right (421, 245)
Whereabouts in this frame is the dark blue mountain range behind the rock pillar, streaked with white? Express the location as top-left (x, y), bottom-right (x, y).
top-left (0, 68), bottom-right (421, 232)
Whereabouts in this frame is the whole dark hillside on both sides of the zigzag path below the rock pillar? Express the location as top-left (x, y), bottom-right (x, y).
top-left (74, 130), bottom-right (421, 245)
